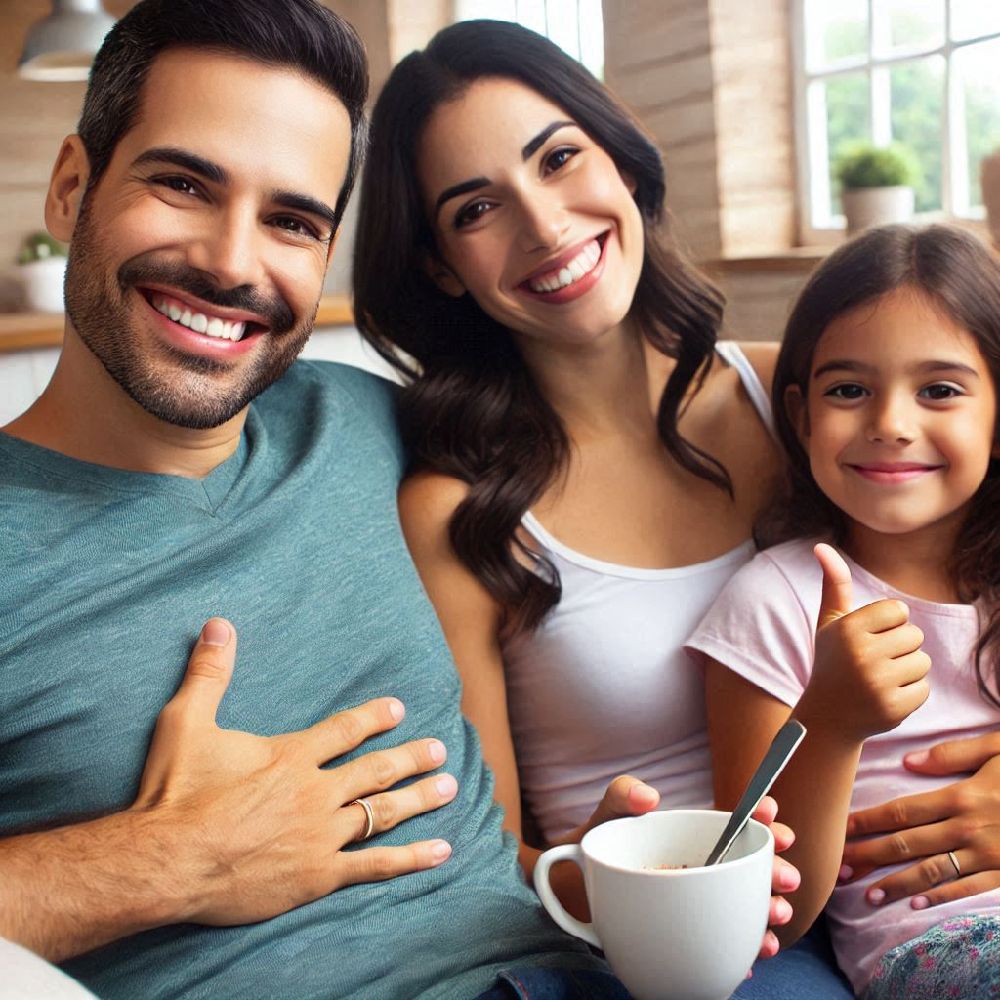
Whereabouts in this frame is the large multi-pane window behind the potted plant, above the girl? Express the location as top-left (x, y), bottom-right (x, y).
top-left (794, 0), bottom-right (1000, 233)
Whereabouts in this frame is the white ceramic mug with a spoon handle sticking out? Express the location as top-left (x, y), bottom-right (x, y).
top-left (535, 809), bottom-right (774, 1000)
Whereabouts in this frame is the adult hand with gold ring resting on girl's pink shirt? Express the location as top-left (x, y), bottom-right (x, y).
top-left (842, 732), bottom-right (1000, 910)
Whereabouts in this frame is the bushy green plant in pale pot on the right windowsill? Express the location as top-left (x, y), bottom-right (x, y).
top-left (835, 143), bottom-right (920, 233)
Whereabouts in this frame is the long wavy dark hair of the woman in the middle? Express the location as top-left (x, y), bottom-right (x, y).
top-left (354, 21), bottom-right (732, 634)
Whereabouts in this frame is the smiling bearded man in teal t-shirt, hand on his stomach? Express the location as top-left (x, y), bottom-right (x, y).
top-left (0, 0), bottom-right (796, 1000)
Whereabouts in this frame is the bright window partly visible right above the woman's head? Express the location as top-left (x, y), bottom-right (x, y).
top-left (455, 0), bottom-right (604, 80)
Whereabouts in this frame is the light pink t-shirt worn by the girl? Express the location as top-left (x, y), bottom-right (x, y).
top-left (686, 541), bottom-right (1000, 993)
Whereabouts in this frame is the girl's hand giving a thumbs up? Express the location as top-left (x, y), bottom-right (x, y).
top-left (795, 544), bottom-right (931, 742)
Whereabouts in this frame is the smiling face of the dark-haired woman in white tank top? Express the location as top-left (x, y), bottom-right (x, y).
top-left (417, 78), bottom-right (643, 346)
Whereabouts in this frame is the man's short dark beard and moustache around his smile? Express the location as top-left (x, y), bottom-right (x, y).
top-left (65, 197), bottom-right (312, 430)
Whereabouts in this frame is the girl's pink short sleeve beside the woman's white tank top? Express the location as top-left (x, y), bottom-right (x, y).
top-left (684, 552), bottom-right (818, 706)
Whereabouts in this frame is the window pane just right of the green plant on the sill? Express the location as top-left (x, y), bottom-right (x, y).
top-left (889, 56), bottom-right (944, 212)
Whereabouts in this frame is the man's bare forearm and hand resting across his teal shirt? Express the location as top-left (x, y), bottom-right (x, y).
top-left (0, 619), bottom-right (457, 961)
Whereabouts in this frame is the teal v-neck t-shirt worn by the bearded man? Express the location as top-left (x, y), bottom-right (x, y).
top-left (0, 362), bottom-right (597, 1000)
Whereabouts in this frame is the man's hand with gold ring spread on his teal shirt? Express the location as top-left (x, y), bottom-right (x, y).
top-left (132, 618), bottom-right (457, 924)
